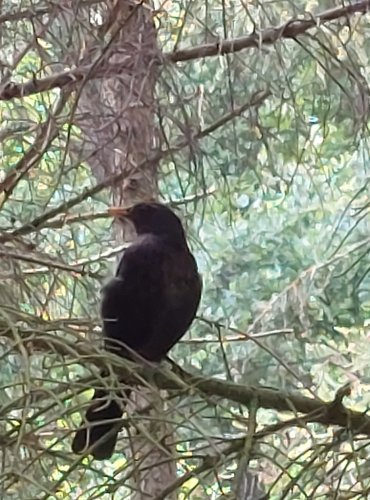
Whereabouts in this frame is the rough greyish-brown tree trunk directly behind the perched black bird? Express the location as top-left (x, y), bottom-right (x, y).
top-left (67, 1), bottom-right (176, 500)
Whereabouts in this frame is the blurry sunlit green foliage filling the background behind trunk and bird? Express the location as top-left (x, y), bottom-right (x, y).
top-left (0, 1), bottom-right (370, 500)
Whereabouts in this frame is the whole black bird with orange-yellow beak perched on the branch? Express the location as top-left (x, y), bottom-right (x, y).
top-left (72, 203), bottom-right (202, 460)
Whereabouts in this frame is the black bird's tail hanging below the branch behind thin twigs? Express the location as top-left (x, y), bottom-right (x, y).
top-left (72, 390), bottom-right (128, 460)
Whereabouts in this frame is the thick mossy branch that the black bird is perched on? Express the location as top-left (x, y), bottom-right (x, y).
top-left (3, 329), bottom-right (370, 435)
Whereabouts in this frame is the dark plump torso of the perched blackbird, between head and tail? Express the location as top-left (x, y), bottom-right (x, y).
top-left (102, 238), bottom-right (201, 361)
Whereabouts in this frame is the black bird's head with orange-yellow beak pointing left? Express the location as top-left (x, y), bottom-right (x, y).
top-left (108, 202), bottom-right (185, 243)
